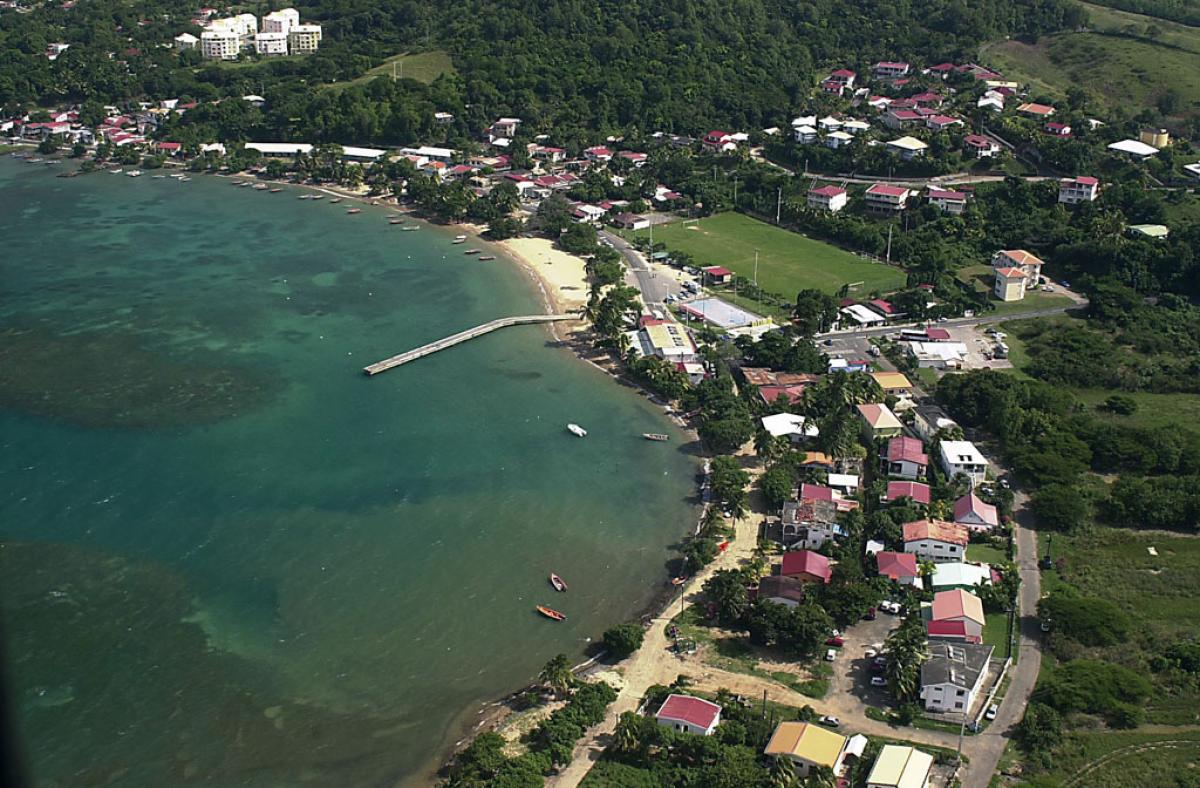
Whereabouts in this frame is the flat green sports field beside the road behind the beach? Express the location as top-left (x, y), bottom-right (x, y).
top-left (634, 213), bottom-right (905, 299)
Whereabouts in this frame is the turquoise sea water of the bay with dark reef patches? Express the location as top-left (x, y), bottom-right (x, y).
top-left (0, 158), bottom-right (696, 786)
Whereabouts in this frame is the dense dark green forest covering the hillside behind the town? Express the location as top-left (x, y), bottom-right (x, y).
top-left (0, 0), bottom-right (1084, 144)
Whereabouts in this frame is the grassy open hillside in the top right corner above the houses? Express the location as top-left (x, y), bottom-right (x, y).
top-left (983, 4), bottom-right (1200, 115)
